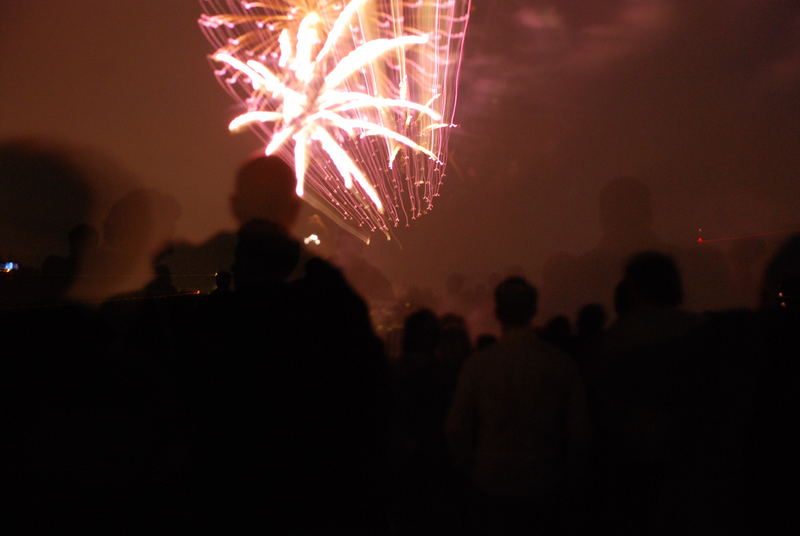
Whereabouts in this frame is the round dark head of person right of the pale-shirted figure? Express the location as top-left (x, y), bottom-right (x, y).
top-left (625, 251), bottom-right (683, 309)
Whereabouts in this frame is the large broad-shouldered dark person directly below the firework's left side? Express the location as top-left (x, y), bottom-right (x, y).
top-left (188, 157), bottom-right (388, 533)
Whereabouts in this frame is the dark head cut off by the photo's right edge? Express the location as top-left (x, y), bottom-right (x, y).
top-left (761, 234), bottom-right (800, 309)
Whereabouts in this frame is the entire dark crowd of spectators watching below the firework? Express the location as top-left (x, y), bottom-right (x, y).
top-left (0, 140), bottom-right (800, 536)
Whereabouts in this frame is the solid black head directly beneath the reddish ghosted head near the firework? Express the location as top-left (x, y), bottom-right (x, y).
top-left (233, 220), bottom-right (300, 290)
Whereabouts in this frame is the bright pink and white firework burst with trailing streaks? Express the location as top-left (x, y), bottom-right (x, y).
top-left (200, 0), bottom-right (470, 236)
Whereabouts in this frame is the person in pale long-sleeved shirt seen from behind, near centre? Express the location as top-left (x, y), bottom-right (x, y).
top-left (446, 277), bottom-right (589, 534)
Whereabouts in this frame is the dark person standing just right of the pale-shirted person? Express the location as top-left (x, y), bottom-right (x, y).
top-left (585, 252), bottom-right (702, 534)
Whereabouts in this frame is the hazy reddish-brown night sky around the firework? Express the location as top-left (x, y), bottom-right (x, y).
top-left (0, 0), bottom-right (800, 314)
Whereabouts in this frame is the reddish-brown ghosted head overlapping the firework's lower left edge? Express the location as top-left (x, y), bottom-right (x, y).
top-left (231, 156), bottom-right (300, 230)
